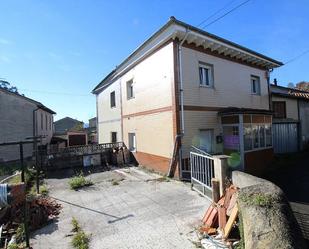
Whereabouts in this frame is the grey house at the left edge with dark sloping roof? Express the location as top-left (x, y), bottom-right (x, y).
top-left (0, 88), bottom-right (56, 161)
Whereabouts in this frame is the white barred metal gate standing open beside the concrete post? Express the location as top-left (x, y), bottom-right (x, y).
top-left (190, 148), bottom-right (215, 197)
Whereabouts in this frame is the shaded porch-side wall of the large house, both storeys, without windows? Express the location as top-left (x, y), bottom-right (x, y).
top-left (182, 47), bottom-right (269, 158)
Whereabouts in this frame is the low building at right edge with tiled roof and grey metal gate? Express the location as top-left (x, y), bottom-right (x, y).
top-left (270, 81), bottom-right (309, 153)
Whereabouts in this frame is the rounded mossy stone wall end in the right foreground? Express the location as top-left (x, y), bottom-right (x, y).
top-left (232, 171), bottom-right (306, 249)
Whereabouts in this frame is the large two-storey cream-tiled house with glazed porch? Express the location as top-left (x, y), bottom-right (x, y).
top-left (92, 17), bottom-right (282, 178)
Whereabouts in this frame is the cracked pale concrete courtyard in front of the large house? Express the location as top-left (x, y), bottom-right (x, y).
top-left (31, 167), bottom-right (210, 249)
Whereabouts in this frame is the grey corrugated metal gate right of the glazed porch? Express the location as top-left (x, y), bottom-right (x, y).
top-left (273, 122), bottom-right (298, 153)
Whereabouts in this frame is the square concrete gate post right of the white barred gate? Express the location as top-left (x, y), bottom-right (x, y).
top-left (213, 155), bottom-right (229, 196)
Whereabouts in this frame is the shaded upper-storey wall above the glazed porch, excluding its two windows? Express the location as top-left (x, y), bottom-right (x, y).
top-left (183, 48), bottom-right (269, 110)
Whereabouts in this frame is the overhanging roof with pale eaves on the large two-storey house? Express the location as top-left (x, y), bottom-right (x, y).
top-left (92, 17), bottom-right (283, 94)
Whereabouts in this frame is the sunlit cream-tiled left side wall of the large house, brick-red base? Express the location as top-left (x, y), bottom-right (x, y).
top-left (97, 42), bottom-right (174, 173)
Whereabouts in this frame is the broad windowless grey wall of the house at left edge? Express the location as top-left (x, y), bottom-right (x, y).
top-left (0, 91), bottom-right (36, 161)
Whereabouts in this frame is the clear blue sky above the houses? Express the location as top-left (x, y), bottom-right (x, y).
top-left (0, 0), bottom-right (309, 122)
